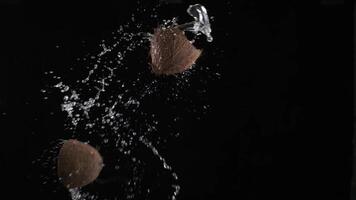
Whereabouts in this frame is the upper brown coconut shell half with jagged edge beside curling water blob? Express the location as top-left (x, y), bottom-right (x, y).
top-left (150, 27), bottom-right (201, 75)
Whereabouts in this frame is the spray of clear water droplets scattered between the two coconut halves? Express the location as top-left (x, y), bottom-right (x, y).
top-left (43, 24), bottom-right (180, 200)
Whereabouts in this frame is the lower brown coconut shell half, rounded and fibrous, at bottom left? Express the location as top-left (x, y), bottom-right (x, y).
top-left (57, 140), bottom-right (103, 188)
